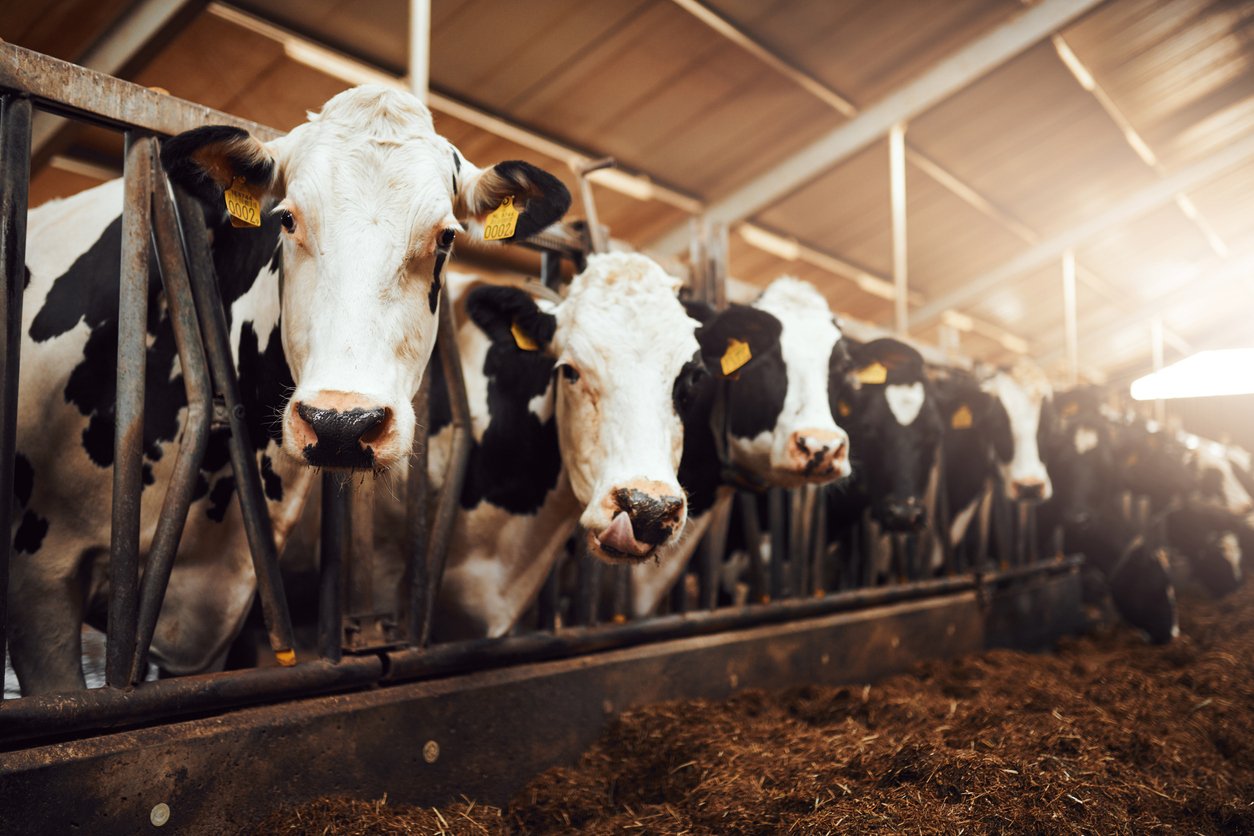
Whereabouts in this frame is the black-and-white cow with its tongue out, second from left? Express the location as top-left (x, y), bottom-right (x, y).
top-left (411, 253), bottom-right (707, 639)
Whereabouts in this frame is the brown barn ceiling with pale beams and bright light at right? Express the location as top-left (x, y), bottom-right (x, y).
top-left (9, 0), bottom-right (1254, 441)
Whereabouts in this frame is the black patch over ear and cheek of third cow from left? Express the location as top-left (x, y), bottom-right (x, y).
top-left (697, 305), bottom-right (788, 439)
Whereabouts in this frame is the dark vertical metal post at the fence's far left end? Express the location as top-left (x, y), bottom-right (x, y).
top-left (0, 95), bottom-right (31, 699)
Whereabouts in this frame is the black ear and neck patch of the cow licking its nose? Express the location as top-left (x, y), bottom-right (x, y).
top-left (430, 287), bottom-right (562, 514)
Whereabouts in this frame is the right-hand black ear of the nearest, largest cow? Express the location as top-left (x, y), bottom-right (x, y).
top-left (454, 154), bottom-right (571, 241)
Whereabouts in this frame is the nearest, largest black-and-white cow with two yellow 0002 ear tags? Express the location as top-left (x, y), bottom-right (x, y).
top-left (9, 85), bottom-right (569, 694)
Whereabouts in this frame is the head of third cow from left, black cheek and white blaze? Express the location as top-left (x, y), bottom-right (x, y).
top-left (698, 277), bottom-right (849, 488)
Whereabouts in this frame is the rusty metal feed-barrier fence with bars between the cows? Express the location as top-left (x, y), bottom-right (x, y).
top-left (0, 43), bottom-right (1073, 747)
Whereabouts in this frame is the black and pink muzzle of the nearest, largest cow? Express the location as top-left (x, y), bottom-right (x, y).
top-left (286, 391), bottom-right (396, 470)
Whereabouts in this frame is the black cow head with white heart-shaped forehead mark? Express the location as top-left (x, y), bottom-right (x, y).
top-left (830, 338), bottom-right (942, 531)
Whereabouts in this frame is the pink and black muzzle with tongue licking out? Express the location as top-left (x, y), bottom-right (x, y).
top-left (588, 483), bottom-right (687, 563)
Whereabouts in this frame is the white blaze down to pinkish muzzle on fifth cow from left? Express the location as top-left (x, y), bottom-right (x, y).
top-left (982, 361), bottom-right (1053, 500)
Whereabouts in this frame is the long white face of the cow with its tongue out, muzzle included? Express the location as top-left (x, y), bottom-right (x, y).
top-left (552, 253), bottom-right (697, 562)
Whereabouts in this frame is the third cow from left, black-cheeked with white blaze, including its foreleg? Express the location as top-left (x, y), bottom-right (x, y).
top-left (631, 276), bottom-right (850, 617)
